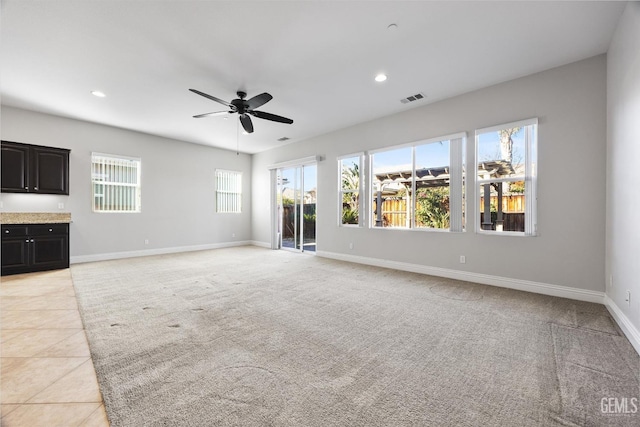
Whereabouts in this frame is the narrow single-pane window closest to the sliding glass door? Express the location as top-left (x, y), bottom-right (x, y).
top-left (338, 155), bottom-right (362, 225)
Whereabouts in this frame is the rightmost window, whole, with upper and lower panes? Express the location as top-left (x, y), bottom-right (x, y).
top-left (476, 119), bottom-right (538, 236)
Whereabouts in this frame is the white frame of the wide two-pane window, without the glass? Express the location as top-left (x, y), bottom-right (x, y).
top-left (366, 132), bottom-right (467, 233)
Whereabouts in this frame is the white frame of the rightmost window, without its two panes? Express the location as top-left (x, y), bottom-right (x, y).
top-left (474, 117), bottom-right (538, 237)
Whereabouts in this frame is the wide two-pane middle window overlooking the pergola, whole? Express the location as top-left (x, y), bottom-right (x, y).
top-left (370, 133), bottom-right (466, 231)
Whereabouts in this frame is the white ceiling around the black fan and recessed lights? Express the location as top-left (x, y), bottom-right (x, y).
top-left (0, 0), bottom-right (625, 153)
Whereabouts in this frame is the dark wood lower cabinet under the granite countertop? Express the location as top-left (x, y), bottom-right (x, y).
top-left (2, 224), bottom-right (69, 276)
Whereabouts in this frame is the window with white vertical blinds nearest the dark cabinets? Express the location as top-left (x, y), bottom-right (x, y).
top-left (91, 153), bottom-right (141, 212)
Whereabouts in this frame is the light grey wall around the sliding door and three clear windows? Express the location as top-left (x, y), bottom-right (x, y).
top-left (252, 55), bottom-right (608, 296)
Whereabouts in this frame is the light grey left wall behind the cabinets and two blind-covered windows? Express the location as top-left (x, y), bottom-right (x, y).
top-left (1, 106), bottom-right (251, 262)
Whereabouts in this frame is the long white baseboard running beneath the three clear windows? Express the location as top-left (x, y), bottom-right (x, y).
top-left (317, 251), bottom-right (605, 304)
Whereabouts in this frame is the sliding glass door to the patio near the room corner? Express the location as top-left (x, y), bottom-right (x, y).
top-left (276, 164), bottom-right (317, 251)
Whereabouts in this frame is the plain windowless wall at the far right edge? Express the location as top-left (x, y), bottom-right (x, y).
top-left (606, 2), bottom-right (640, 342)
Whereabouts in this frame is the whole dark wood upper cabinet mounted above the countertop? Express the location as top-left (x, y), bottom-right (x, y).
top-left (2, 141), bottom-right (69, 194)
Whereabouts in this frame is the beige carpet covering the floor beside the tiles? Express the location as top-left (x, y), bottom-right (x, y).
top-left (72, 247), bottom-right (640, 427)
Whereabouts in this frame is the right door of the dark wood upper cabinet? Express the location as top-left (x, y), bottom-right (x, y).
top-left (31, 147), bottom-right (69, 194)
